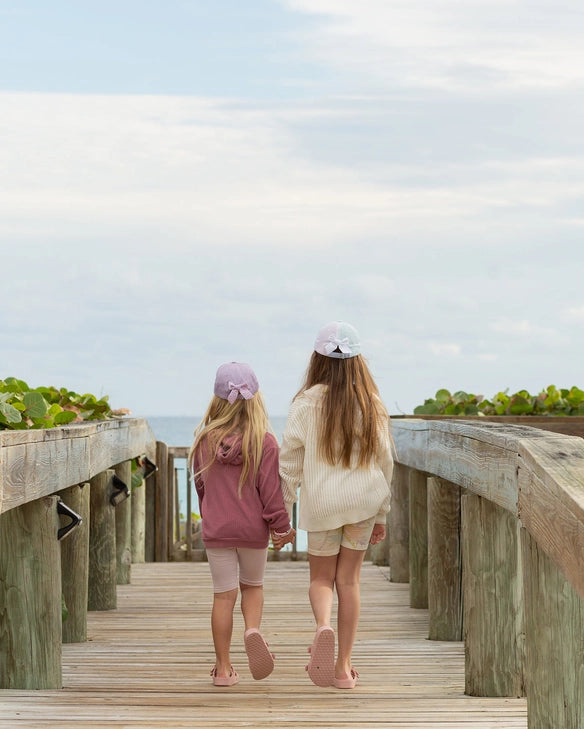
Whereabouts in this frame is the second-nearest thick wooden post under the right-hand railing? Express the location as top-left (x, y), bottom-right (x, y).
top-left (461, 493), bottom-right (524, 696)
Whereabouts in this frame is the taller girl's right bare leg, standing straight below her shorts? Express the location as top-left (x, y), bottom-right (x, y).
top-left (335, 547), bottom-right (365, 678)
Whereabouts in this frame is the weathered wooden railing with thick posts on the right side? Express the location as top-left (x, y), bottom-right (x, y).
top-left (389, 419), bottom-right (584, 729)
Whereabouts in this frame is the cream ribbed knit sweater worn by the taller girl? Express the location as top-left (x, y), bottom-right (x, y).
top-left (280, 385), bottom-right (393, 532)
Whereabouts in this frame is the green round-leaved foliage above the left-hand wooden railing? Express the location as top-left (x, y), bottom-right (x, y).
top-left (0, 377), bottom-right (128, 430)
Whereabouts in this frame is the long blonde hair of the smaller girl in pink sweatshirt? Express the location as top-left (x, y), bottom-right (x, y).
top-left (187, 392), bottom-right (272, 498)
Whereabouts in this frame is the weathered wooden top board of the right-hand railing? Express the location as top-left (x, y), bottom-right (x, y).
top-left (392, 419), bottom-right (584, 599)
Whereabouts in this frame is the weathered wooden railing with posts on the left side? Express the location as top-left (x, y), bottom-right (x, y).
top-left (0, 418), bottom-right (156, 689)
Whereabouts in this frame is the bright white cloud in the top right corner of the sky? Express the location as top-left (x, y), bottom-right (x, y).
top-left (286, 0), bottom-right (584, 96)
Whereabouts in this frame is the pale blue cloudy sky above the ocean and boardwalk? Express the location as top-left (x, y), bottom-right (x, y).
top-left (0, 0), bottom-right (584, 417)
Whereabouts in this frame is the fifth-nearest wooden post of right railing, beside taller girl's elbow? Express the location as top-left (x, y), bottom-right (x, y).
top-left (389, 463), bottom-right (410, 582)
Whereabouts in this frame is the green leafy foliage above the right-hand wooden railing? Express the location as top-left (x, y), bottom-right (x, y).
top-left (414, 385), bottom-right (584, 416)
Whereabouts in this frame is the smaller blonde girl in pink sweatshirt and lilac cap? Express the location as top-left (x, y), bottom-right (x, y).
top-left (188, 362), bottom-right (296, 686)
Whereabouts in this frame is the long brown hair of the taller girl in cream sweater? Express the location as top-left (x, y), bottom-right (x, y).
top-left (296, 352), bottom-right (389, 468)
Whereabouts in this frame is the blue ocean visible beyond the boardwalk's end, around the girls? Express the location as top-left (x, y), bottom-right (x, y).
top-left (146, 415), bottom-right (306, 551)
